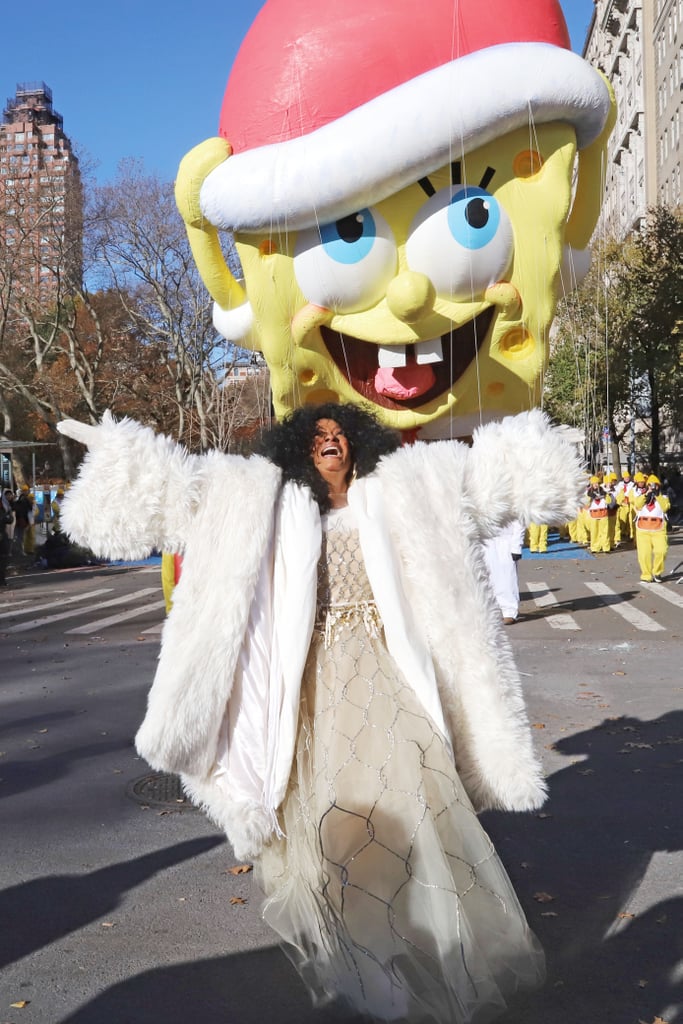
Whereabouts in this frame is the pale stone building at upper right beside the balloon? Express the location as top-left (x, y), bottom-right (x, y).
top-left (584, 0), bottom-right (683, 238)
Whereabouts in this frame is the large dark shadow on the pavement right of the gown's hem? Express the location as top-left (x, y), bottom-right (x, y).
top-left (483, 712), bottom-right (683, 1024)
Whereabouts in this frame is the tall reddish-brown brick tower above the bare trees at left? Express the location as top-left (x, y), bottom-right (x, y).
top-left (0, 82), bottom-right (83, 295)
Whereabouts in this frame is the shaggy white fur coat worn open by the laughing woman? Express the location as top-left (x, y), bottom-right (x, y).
top-left (60, 412), bottom-right (584, 856)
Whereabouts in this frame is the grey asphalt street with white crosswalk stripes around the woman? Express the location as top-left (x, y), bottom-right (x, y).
top-left (0, 530), bottom-right (683, 1024)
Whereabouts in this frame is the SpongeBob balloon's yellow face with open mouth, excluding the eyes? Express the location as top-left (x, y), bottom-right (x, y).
top-left (236, 125), bottom-right (575, 430)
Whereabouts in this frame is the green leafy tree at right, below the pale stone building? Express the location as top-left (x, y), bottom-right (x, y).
top-left (545, 207), bottom-right (683, 469)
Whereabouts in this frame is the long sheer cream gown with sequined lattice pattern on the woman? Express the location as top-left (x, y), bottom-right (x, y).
top-left (256, 509), bottom-right (544, 1024)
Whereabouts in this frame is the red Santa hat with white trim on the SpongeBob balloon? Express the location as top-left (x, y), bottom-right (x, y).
top-left (201, 0), bottom-right (610, 231)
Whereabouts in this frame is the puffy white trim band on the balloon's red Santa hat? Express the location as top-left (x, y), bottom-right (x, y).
top-left (200, 43), bottom-right (610, 231)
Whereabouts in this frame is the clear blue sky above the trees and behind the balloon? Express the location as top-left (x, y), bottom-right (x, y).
top-left (0, 0), bottom-right (593, 182)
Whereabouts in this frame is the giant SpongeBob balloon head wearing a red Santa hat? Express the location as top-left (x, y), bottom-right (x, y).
top-left (176, 0), bottom-right (614, 438)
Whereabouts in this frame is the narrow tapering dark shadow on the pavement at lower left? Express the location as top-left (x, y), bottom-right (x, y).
top-left (0, 836), bottom-right (225, 970)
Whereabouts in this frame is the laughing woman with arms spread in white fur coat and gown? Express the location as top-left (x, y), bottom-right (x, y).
top-left (59, 404), bottom-right (583, 1024)
